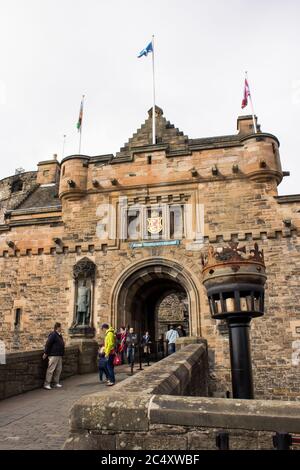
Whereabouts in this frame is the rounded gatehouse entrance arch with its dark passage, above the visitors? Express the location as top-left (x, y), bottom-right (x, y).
top-left (111, 258), bottom-right (201, 339)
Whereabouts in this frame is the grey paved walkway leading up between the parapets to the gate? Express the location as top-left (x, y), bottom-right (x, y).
top-left (0, 366), bottom-right (129, 450)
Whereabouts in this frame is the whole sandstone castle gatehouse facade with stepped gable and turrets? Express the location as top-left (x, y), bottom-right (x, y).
top-left (0, 108), bottom-right (300, 400)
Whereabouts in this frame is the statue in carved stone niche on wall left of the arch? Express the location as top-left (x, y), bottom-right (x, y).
top-left (69, 258), bottom-right (96, 336)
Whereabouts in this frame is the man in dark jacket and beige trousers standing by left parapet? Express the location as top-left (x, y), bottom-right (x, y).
top-left (43, 322), bottom-right (65, 390)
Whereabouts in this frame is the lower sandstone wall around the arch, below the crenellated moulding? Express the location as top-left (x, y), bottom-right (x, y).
top-left (0, 229), bottom-right (300, 398)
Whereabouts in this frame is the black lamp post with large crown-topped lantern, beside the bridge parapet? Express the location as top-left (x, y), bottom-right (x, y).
top-left (202, 242), bottom-right (267, 398)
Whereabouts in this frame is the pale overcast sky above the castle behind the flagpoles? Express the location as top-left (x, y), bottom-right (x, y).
top-left (0, 0), bottom-right (300, 194)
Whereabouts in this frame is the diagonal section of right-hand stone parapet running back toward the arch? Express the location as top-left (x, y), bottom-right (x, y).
top-left (65, 340), bottom-right (208, 449)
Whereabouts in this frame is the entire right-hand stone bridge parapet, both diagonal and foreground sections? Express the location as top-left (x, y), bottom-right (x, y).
top-left (64, 342), bottom-right (300, 450)
